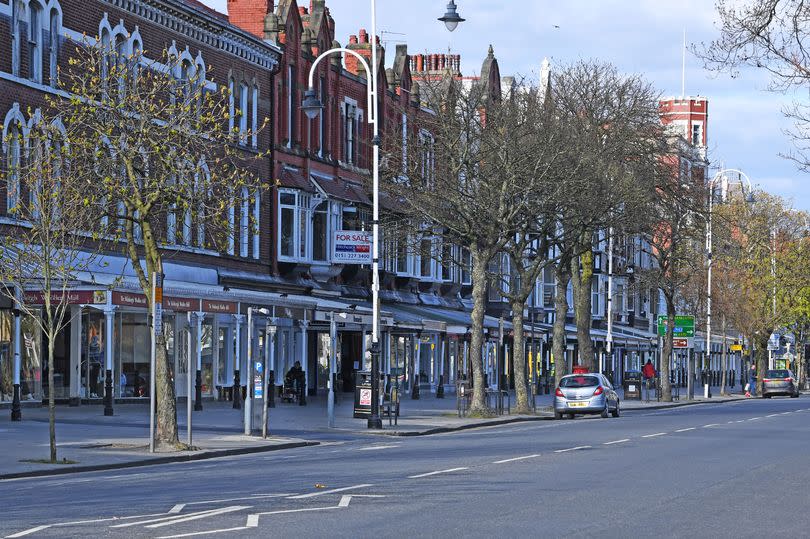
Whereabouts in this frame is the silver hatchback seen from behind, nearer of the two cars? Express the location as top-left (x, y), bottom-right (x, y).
top-left (554, 372), bottom-right (620, 419)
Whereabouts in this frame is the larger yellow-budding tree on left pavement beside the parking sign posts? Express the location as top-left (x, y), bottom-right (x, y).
top-left (38, 42), bottom-right (264, 447)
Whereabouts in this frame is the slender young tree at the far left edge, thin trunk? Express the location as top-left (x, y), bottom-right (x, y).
top-left (0, 119), bottom-right (104, 462)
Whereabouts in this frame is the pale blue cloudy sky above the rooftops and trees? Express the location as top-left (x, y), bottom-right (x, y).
top-left (203, 0), bottom-right (810, 210)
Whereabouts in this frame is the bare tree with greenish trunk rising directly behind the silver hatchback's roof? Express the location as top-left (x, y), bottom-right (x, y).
top-left (550, 60), bottom-right (662, 370)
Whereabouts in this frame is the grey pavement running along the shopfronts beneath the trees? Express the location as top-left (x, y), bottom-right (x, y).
top-left (0, 384), bottom-right (742, 480)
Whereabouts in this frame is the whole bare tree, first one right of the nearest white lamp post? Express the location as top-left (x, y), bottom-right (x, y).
top-left (383, 79), bottom-right (557, 414)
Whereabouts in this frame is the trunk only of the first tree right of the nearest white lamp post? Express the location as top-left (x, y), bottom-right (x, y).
top-left (470, 249), bottom-right (489, 414)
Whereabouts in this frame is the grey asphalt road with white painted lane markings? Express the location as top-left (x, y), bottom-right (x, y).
top-left (0, 397), bottom-right (810, 538)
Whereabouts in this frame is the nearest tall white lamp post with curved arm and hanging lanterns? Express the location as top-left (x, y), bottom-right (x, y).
top-left (301, 0), bottom-right (464, 429)
